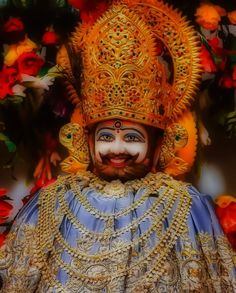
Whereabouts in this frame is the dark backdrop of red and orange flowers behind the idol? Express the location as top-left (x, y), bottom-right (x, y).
top-left (0, 0), bottom-right (236, 246)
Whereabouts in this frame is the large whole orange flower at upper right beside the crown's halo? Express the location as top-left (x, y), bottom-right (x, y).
top-left (195, 3), bottom-right (224, 30)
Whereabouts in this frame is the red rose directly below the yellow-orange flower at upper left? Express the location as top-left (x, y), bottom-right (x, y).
top-left (16, 51), bottom-right (44, 76)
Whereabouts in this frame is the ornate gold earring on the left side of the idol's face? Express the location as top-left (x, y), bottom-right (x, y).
top-left (59, 123), bottom-right (90, 174)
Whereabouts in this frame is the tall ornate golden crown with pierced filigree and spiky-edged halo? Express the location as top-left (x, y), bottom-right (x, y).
top-left (58, 0), bottom-right (200, 128)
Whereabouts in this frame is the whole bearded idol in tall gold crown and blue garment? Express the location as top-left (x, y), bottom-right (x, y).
top-left (0, 0), bottom-right (236, 293)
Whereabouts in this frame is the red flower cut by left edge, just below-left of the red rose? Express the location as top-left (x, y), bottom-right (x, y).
top-left (0, 67), bottom-right (20, 100)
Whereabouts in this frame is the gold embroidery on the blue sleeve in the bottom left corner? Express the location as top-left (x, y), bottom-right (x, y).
top-left (0, 225), bottom-right (42, 293)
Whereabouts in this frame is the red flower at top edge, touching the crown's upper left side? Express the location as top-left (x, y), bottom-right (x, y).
top-left (68, 0), bottom-right (109, 23)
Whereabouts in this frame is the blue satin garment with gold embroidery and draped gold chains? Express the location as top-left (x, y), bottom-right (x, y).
top-left (0, 173), bottom-right (236, 293)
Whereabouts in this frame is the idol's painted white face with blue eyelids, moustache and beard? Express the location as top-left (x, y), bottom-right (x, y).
top-left (91, 120), bottom-right (150, 180)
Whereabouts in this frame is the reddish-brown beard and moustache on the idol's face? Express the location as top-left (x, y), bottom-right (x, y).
top-left (93, 153), bottom-right (151, 182)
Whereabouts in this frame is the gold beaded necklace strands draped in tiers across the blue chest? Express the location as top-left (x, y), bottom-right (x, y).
top-left (38, 173), bottom-right (191, 292)
